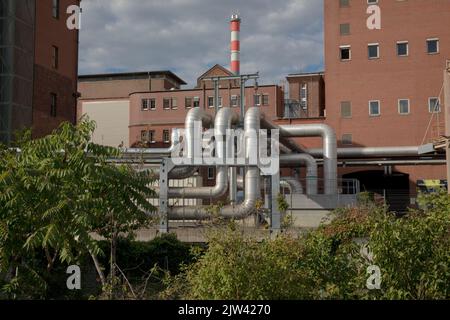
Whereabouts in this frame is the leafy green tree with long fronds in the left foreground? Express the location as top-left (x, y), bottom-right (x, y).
top-left (0, 119), bottom-right (155, 298)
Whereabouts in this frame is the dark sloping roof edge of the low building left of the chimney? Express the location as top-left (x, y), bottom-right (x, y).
top-left (78, 70), bottom-right (187, 84)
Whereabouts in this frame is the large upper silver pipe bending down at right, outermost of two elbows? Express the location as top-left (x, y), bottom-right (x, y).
top-left (280, 124), bottom-right (337, 195)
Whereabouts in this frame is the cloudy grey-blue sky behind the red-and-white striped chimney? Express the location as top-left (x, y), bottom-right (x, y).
top-left (80, 0), bottom-right (323, 86)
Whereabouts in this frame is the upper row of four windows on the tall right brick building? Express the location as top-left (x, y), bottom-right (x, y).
top-left (340, 38), bottom-right (439, 61)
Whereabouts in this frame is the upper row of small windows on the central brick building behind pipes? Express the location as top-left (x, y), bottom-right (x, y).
top-left (141, 94), bottom-right (269, 111)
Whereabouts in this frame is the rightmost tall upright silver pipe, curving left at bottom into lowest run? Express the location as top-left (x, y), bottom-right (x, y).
top-left (168, 108), bottom-right (260, 220)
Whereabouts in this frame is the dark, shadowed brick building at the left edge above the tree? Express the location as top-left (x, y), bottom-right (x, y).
top-left (0, 0), bottom-right (80, 143)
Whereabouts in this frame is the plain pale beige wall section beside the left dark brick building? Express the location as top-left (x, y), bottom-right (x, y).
top-left (81, 100), bottom-right (130, 148)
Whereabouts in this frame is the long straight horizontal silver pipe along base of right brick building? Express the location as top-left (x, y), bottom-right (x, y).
top-left (306, 146), bottom-right (419, 158)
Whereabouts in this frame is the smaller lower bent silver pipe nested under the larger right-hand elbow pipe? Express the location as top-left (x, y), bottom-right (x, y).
top-left (280, 153), bottom-right (319, 195)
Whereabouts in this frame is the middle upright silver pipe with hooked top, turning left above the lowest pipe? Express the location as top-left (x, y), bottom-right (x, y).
top-left (168, 108), bottom-right (239, 199)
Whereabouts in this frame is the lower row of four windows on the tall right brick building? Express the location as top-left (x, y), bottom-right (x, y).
top-left (341, 97), bottom-right (441, 118)
